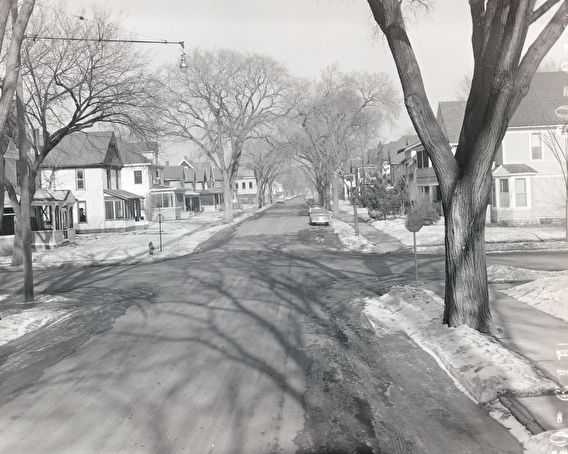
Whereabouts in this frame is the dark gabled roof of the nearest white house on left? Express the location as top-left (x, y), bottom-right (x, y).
top-left (42, 131), bottom-right (122, 168)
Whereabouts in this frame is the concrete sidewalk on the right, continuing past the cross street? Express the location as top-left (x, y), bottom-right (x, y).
top-left (341, 213), bottom-right (568, 435)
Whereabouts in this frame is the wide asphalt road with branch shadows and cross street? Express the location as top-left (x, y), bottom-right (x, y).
top-left (0, 201), bottom-right (522, 454)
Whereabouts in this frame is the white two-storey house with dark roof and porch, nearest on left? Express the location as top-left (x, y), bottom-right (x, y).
top-left (40, 131), bottom-right (147, 233)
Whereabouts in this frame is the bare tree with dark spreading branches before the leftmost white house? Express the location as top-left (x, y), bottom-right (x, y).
top-left (6, 4), bottom-right (161, 299)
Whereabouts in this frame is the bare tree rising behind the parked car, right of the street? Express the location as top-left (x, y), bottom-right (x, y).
top-left (295, 66), bottom-right (398, 217)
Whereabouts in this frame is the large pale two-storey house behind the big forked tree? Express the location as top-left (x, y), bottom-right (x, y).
top-left (390, 72), bottom-right (568, 223)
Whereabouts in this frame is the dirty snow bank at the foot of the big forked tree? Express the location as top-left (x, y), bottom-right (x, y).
top-left (366, 286), bottom-right (557, 403)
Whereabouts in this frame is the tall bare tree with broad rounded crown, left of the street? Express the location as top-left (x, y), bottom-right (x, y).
top-left (158, 49), bottom-right (293, 222)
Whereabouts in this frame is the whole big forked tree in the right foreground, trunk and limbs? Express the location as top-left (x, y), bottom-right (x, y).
top-left (368, 0), bottom-right (568, 332)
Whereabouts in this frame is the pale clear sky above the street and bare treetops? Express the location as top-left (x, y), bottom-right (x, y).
top-left (45, 0), bottom-right (568, 160)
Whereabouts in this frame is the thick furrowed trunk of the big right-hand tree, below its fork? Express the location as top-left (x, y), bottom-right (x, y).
top-left (443, 182), bottom-right (494, 333)
